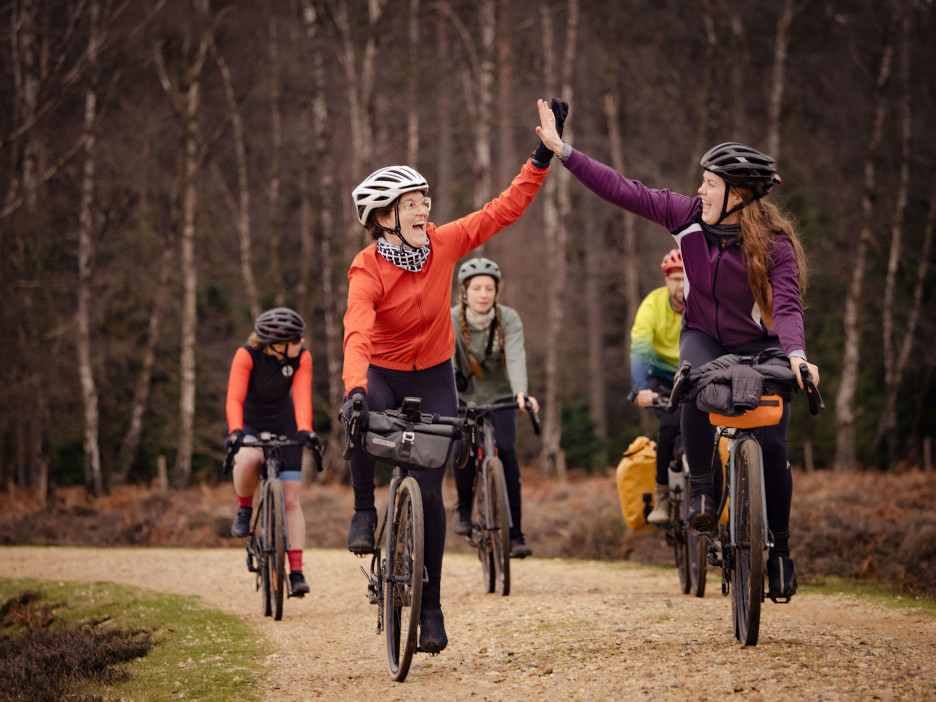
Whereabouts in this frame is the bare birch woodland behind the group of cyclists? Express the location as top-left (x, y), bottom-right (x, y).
top-left (0, 0), bottom-right (936, 495)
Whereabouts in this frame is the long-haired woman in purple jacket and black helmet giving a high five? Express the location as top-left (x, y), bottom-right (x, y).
top-left (536, 102), bottom-right (819, 597)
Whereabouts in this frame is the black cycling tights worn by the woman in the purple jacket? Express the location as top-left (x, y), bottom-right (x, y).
top-left (679, 328), bottom-right (793, 556)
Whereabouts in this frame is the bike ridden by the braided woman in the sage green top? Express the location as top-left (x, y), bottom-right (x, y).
top-left (460, 398), bottom-right (540, 597)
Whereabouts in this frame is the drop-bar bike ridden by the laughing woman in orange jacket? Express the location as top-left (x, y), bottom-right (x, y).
top-left (341, 397), bottom-right (467, 682)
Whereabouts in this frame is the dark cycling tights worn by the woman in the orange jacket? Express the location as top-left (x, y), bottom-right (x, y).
top-left (351, 361), bottom-right (457, 609)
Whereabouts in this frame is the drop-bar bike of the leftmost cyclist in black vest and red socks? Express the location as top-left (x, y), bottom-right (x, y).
top-left (224, 432), bottom-right (322, 621)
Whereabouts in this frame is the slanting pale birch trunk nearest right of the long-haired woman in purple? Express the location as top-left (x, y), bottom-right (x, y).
top-left (834, 15), bottom-right (896, 471)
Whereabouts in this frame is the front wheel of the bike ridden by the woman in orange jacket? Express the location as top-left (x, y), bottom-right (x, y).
top-left (384, 477), bottom-right (424, 682)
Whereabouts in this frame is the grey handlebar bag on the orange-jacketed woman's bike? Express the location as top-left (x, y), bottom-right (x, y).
top-left (364, 410), bottom-right (461, 469)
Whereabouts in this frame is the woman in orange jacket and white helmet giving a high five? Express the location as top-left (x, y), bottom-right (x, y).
top-left (342, 98), bottom-right (568, 653)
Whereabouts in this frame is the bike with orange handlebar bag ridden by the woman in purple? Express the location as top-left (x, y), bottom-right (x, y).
top-left (668, 362), bottom-right (825, 646)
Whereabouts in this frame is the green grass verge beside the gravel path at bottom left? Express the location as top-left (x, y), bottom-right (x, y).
top-left (0, 578), bottom-right (268, 702)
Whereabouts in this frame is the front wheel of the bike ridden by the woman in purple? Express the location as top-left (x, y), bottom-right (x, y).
top-left (731, 439), bottom-right (764, 646)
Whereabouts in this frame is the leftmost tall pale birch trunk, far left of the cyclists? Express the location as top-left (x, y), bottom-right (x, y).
top-left (76, 1), bottom-right (104, 497)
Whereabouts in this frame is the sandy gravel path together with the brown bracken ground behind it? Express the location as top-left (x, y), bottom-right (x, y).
top-left (0, 471), bottom-right (936, 700)
